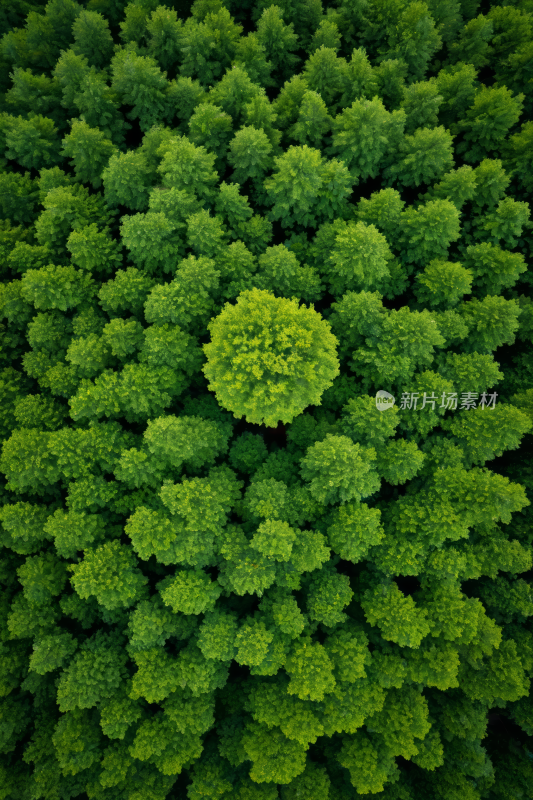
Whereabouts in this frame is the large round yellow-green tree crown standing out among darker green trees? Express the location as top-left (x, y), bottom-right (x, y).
top-left (204, 289), bottom-right (338, 426)
